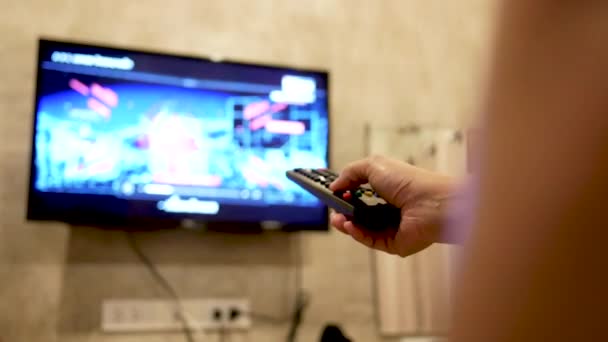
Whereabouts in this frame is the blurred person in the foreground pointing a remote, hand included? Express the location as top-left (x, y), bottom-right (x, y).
top-left (331, 0), bottom-right (608, 342)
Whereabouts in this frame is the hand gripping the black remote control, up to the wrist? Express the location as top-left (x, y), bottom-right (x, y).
top-left (330, 156), bottom-right (455, 257)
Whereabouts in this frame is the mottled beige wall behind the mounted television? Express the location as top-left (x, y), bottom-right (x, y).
top-left (0, 0), bottom-right (492, 342)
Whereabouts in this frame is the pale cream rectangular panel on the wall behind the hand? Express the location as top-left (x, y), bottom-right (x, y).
top-left (366, 125), bottom-right (466, 336)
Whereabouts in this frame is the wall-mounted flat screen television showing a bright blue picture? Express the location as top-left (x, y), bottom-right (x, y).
top-left (27, 39), bottom-right (329, 230)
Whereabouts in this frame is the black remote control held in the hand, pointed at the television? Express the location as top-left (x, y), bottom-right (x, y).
top-left (287, 169), bottom-right (401, 231)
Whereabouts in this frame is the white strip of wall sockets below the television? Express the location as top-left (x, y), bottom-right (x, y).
top-left (101, 298), bottom-right (251, 332)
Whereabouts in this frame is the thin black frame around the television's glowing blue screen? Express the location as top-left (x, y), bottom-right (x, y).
top-left (26, 37), bottom-right (331, 232)
